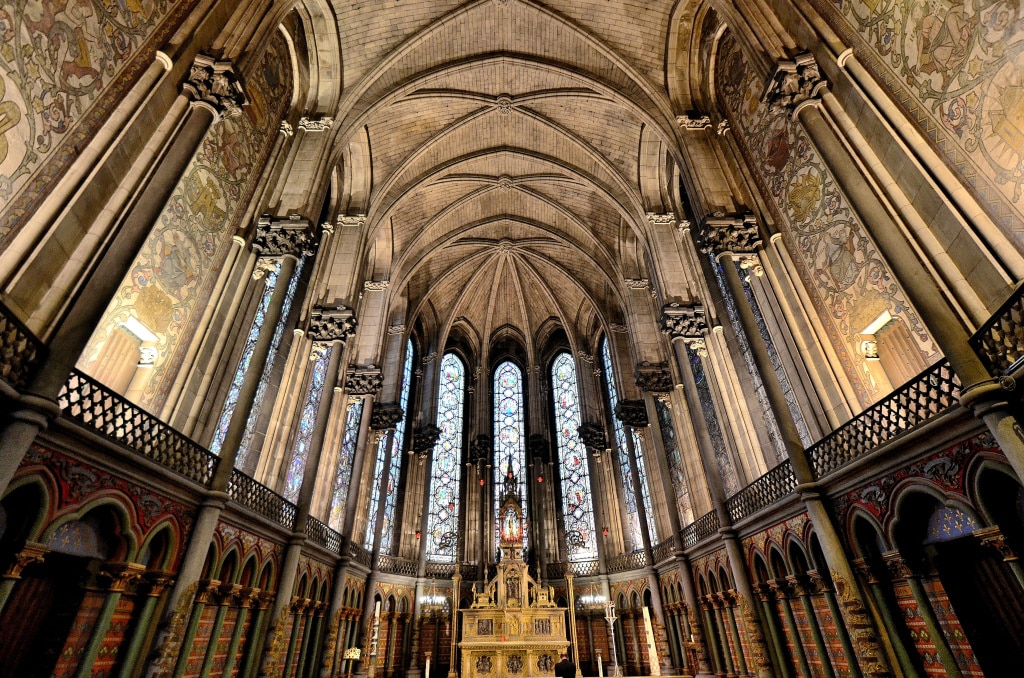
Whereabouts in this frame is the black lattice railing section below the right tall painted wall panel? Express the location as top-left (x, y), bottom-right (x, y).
top-left (807, 361), bottom-right (961, 478)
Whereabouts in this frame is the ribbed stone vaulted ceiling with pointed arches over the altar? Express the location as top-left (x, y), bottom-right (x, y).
top-left (323, 0), bottom-right (679, 358)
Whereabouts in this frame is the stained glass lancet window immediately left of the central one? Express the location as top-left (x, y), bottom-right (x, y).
top-left (427, 353), bottom-right (466, 562)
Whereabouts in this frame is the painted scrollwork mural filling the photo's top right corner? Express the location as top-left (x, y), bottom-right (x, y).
top-left (813, 0), bottom-right (1024, 241)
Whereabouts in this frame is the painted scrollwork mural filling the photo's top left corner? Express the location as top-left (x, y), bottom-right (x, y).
top-left (0, 0), bottom-right (197, 249)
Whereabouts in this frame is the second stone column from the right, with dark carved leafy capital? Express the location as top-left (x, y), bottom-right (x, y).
top-left (703, 216), bottom-right (890, 676)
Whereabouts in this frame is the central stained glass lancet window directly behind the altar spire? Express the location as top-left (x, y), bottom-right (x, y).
top-left (495, 361), bottom-right (529, 549)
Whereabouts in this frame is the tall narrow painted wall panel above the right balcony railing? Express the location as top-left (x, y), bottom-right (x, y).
top-left (718, 36), bottom-right (937, 406)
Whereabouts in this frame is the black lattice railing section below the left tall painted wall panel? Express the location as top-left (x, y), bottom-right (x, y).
top-left (57, 370), bottom-right (218, 485)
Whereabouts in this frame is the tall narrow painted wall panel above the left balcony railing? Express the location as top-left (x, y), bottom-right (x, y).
top-left (79, 33), bottom-right (291, 411)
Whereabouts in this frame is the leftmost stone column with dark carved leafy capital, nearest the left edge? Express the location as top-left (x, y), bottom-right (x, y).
top-left (0, 54), bottom-right (246, 492)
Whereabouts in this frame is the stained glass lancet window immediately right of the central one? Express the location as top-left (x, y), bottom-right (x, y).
top-left (551, 353), bottom-right (597, 560)
